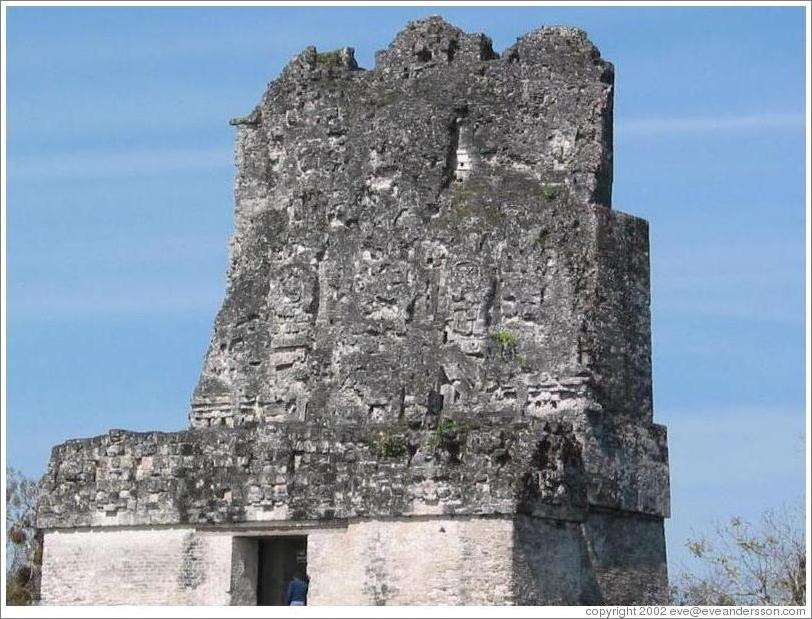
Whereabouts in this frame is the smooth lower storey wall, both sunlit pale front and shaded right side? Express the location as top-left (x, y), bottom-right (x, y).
top-left (42, 512), bottom-right (667, 606)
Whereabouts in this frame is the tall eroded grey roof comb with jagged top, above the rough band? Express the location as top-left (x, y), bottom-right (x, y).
top-left (191, 19), bottom-right (624, 427)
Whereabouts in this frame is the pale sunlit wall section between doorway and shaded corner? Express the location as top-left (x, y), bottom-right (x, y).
top-left (308, 518), bottom-right (513, 605)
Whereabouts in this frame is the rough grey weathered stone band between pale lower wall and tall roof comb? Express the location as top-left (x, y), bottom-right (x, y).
top-left (38, 412), bottom-right (669, 529)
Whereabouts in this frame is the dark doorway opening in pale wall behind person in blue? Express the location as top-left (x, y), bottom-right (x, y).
top-left (257, 535), bottom-right (307, 606)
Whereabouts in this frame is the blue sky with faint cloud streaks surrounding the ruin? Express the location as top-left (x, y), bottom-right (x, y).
top-left (5, 7), bottom-right (806, 576)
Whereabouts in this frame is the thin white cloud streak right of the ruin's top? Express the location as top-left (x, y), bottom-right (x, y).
top-left (615, 113), bottom-right (804, 137)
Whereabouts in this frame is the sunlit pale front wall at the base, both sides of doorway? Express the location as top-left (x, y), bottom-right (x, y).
top-left (42, 518), bottom-right (513, 605)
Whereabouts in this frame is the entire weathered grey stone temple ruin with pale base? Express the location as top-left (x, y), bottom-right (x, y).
top-left (38, 17), bottom-right (669, 605)
